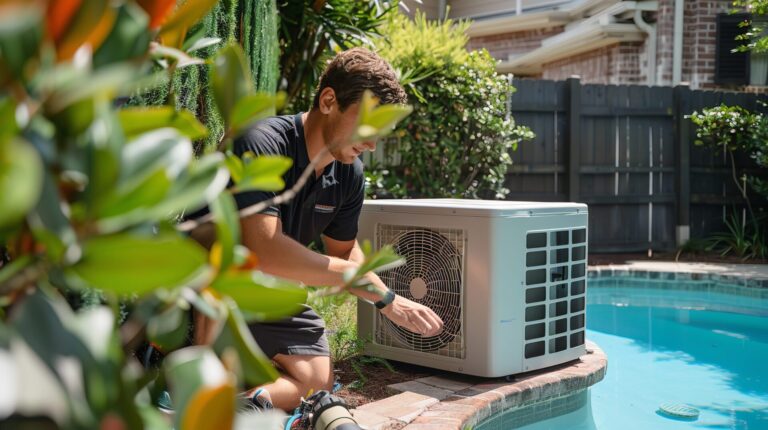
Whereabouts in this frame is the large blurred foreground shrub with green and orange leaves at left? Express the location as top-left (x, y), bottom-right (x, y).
top-left (0, 0), bottom-right (410, 429)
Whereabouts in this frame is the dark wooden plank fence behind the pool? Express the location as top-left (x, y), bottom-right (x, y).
top-left (506, 78), bottom-right (764, 252)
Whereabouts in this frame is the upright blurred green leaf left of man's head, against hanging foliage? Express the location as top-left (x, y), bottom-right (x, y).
top-left (210, 43), bottom-right (253, 130)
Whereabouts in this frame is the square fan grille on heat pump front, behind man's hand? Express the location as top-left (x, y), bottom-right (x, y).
top-left (376, 224), bottom-right (464, 358)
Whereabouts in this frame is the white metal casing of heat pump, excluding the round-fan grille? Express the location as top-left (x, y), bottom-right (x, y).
top-left (358, 199), bottom-right (588, 377)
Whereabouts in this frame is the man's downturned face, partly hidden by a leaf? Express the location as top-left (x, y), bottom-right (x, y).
top-left (326, 103), bottom-right (376, 164)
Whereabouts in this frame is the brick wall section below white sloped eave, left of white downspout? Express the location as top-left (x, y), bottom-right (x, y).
top-left (541, 42), bottom-right (646, 85)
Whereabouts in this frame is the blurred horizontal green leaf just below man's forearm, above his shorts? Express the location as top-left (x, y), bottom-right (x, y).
top-left (211, 271), bottom-right (307, 321)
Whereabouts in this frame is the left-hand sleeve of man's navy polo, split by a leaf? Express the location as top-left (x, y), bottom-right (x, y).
top-left (232, 128), bottom-right (285, 216)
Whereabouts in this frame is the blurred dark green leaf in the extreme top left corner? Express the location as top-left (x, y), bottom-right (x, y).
top-left (0, 4), bottom-right (44, 78)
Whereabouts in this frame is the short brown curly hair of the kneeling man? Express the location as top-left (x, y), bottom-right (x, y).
top-left (312, 48), bottom-right (408, 111)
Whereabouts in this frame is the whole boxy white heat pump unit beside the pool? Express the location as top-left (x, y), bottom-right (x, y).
top-left (358, 199), bottom-right (587, 377)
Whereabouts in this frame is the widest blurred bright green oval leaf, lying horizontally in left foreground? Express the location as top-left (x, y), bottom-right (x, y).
top-left (66, 234), bottom-right (207, 295)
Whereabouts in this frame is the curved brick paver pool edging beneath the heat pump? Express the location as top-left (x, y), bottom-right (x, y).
top-left (353, 341), bottom-right (608, 430)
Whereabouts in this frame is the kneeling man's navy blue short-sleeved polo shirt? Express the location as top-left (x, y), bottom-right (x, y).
top-left (233, 114), bottom-right (365, 245)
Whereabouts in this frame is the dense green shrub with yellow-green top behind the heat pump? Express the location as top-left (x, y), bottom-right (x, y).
top-left (368, 14), bottom-right (532, 198)
